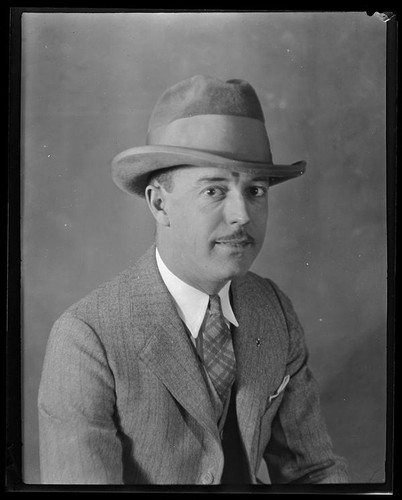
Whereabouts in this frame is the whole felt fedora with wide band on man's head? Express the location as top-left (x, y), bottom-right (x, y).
top-left (112, 75), bottom-right (306, 196)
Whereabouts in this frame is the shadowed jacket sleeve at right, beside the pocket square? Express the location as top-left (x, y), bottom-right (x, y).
top-left (264, 284), bottom-right (349, 483)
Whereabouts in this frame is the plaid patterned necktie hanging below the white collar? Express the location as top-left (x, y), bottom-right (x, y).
top-left (203, 295), bottom-right (236, 401)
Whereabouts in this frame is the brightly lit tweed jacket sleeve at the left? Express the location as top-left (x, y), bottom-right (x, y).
top-left (38, 313), bottom-right (123, 484)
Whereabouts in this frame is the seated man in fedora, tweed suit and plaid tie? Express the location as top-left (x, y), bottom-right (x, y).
top-left (39, 76), bottom-right (347, 485)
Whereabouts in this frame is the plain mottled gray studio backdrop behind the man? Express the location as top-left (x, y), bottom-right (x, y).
top-left (22, 12), bottom-right (387, 483)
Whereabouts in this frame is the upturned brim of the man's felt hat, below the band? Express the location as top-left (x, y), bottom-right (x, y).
top-left (112, 146), bottom-right (306, 196)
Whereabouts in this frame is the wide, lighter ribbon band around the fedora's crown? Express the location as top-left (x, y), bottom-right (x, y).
top-left (147, 115), bottom-right (272, 163)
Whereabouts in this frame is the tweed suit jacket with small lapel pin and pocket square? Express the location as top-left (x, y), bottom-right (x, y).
top-left (38, 246), bottom-right (348, 484)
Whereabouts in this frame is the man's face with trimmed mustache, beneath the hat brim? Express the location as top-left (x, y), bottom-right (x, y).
top-left (158, 167), bottom-right (268, 293)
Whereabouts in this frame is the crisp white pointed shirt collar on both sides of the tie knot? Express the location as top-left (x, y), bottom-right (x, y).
top-left (156, 249), bottom-right (239, 338)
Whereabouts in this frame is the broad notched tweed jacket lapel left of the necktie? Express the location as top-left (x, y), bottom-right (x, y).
top-left (134, 246), bottom-right (218, 439)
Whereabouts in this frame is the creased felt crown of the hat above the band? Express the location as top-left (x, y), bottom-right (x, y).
top-left (148, 75), bottom-right (265, 131)
